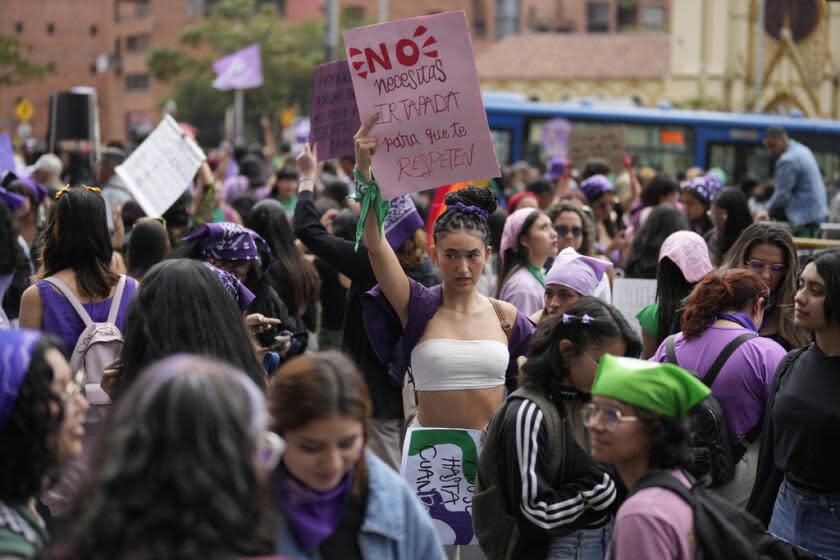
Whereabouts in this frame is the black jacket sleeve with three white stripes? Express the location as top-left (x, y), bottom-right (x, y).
top-left (503, 399), bottom-right (616, 535)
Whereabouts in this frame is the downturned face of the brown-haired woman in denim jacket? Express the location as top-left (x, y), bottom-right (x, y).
top-left (282, 416), bottom-right (365, 492)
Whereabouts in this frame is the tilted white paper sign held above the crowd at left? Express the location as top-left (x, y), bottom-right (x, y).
top-left (116, 115), bottom-right (205, 216)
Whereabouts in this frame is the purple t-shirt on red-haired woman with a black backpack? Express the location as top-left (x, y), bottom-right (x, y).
top-left (651, 326), bottom-right (787, 441)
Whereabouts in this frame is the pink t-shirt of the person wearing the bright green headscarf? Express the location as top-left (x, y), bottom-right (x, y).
top-left (607, 470), bottom-right (696, 560)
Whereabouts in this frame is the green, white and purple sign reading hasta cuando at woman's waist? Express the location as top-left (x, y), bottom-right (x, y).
top-left (400, 428), bottom-right (481, 545)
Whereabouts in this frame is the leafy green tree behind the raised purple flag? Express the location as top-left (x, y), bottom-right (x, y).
top-left (147, 0), bottom-right (368, 147)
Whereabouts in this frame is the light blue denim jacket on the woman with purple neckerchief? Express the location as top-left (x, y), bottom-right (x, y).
top-left (277, 451), bottom-right (446, 560)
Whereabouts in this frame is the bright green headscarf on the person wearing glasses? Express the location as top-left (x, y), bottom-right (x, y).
top-left (592, 354), bottom-right (711, 417)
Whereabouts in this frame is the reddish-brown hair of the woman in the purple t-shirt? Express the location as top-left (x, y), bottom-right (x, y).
top-left (681, 268), bottom-right (769, 338)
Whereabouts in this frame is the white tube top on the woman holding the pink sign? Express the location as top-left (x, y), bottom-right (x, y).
top-left (411, 338), bottom-right (510, 391)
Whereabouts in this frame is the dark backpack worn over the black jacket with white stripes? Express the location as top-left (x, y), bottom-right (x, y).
top-left (472, 387), bottom-right (566, 560)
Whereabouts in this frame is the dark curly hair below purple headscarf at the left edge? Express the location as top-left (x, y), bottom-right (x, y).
top-left (0, 335), bottom-right (64, 504)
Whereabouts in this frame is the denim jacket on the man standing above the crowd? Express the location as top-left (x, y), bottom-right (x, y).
top-left (767, 140), bottom-right (828, 227)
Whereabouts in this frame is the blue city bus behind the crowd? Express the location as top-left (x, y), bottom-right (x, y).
top-left (484, 92), bottom-right (840, 183)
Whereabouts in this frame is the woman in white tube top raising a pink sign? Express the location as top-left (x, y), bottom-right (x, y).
top-left (355, 112), bottom-right (535, 430)
